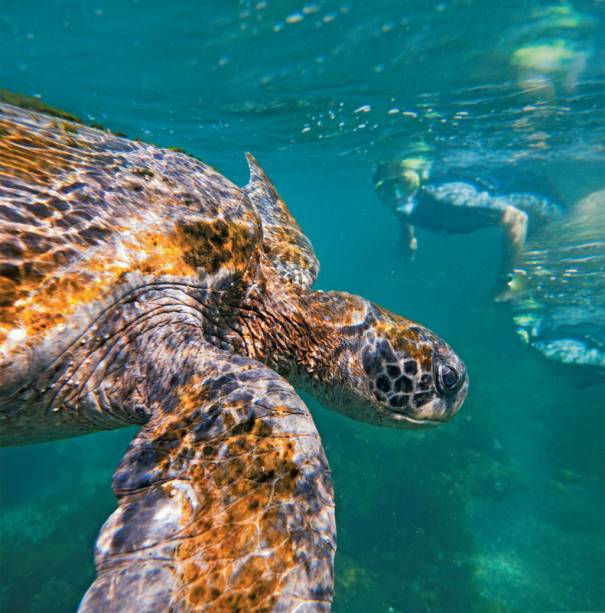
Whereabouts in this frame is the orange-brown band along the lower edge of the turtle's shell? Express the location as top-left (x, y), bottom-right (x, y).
top-left (0, 222), bottom-right (254, 344)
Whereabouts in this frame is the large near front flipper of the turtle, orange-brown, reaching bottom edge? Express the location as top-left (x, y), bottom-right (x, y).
top-left (80, 348), bottom-right (335, 613)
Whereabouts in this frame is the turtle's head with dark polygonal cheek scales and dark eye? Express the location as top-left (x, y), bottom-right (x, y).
top-left (306, 292), bottom-right (468, 428)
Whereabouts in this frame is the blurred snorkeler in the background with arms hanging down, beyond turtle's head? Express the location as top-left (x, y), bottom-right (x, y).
top-left (374, 158), bottom-right (563, 291)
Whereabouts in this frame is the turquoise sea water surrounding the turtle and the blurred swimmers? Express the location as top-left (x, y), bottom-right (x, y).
top-left (0, 0), bottom-right (605, 612)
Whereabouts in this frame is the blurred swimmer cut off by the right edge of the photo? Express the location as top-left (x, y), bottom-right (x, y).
top-left (504, 190), bottom-right (605, 372)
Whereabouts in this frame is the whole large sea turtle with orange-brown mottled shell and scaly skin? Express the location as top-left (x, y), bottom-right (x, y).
top-left (0, 104), bottom-right (468, 613)
